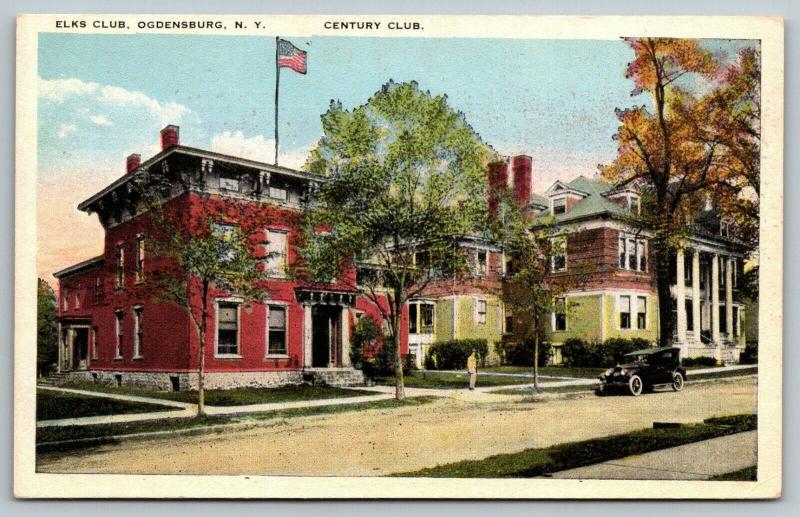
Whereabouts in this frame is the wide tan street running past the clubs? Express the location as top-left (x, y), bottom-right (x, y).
top-left (39, 377), bottom-right (756, 476)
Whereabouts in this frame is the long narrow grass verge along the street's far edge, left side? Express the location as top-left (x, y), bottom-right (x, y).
top-left (36, 396), bottom-right (437, 451)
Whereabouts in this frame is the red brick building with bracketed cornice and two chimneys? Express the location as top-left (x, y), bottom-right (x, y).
top-left (55, 126), bottom-right (400, 389)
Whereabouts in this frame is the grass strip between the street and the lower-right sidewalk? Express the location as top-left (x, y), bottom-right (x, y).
top-left (399, 415), bottom-right (757, 478)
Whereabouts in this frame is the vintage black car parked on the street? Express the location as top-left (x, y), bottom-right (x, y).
top-left (597, 347), bottom-right (686, 397)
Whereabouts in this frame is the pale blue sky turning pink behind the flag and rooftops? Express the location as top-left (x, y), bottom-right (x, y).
top-left (38, 34), bottom-right (743, 278)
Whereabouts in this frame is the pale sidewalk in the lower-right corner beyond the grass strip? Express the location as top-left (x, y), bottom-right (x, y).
top-left (548, 431), bottom-right (758, 480)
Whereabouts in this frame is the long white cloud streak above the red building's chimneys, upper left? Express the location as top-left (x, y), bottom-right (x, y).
top-left (39, 77), bottom-right (191, 125)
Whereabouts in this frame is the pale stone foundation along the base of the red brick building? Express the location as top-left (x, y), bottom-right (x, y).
top-left (56, 368), bottom-right (364, 391)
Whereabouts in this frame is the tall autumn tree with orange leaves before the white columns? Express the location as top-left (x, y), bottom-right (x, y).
top-left (601, 38), bottom-right (760, 346)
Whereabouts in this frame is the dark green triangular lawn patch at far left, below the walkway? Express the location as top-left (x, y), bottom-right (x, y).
top-left (36, 390), bottom-right (175, 420)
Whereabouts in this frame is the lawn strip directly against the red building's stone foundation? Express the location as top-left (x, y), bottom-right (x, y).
top-left (57, 382), bottom-right (375, 406)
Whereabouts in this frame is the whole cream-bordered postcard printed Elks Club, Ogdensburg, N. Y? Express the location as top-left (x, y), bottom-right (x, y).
top-left (14, 14), bottom-right (783, 499)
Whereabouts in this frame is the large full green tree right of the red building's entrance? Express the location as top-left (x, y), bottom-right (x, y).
top-left (300, 81), bottom-right (494, 399)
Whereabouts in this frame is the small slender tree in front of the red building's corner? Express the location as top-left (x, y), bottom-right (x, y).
top-left (139, 179), bottom-right (268, 416)
